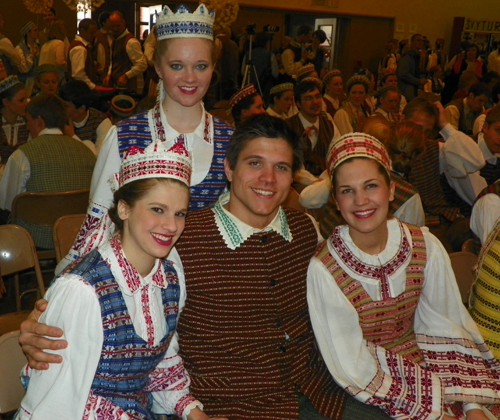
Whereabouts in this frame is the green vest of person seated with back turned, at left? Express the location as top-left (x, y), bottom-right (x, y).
top-left (19, 134), bottom-right (96, 249)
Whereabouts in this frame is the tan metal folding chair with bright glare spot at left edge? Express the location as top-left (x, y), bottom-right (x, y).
top-left (0, 225), bottom-right (45, 312)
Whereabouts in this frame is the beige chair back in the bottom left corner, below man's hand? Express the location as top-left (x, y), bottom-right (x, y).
top-left (0, 330), bottom-right (26, 413)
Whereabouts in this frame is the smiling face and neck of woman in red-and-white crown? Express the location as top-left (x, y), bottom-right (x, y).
top-left (118, 181), bottom-right (189, 276)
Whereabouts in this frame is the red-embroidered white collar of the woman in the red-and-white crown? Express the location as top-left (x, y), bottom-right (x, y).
top-left (99, 236), bottom-right (168, 296)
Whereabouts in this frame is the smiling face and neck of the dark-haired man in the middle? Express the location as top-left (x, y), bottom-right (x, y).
top-left (224, 137), bottom-right (293, 229)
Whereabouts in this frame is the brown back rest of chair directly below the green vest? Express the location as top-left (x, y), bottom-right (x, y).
top-left (11, 189), bottom-right (89, 226)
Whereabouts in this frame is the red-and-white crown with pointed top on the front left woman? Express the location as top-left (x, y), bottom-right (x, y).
top-left (118, 139), bottom-right (191, 187)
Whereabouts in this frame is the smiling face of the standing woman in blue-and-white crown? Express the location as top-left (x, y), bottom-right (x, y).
top-left (155, 38), bottom-right (214, 109)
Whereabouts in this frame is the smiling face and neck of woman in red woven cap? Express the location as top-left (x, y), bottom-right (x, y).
top-left (334, 158), bottom-right (394, 253)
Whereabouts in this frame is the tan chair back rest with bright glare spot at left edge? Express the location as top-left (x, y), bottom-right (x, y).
top-left (0, 225), bottom-right (39, 278)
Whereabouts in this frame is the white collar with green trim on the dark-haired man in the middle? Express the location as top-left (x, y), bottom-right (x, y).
top-left (212, 191), bottom-right (293, 250)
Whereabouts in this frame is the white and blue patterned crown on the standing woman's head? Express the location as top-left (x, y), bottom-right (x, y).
top-left (156, 4), bottom-right (215, 41)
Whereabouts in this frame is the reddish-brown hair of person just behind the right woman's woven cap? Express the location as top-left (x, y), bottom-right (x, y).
top-left (386, 121), bottom-right (426, 178)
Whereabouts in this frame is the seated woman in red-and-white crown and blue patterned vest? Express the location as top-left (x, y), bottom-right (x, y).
top-left (17, 140), bottom-right (227, 420)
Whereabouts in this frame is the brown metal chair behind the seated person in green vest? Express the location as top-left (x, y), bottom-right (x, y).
top-left (11, 189), bottom-right (89, 260)
